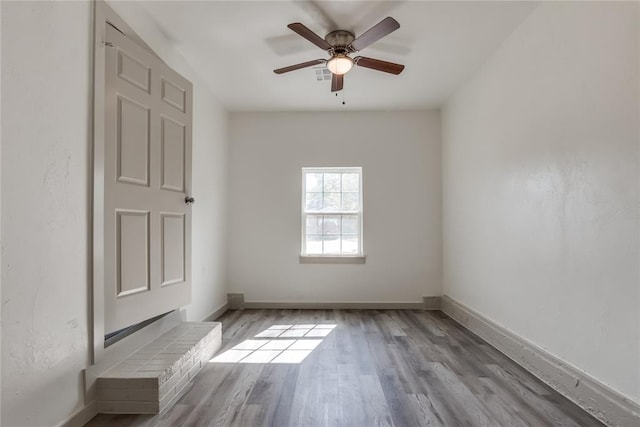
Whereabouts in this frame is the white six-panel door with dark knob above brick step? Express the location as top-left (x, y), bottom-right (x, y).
top-left (102, 26), bottom-right (192, 333)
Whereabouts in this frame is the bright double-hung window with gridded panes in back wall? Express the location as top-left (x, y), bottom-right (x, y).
top-left (301, 168), bottom-right (363, 261)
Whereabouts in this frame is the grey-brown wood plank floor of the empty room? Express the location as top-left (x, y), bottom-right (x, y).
top-left (88, 310), bottom-right (602, 427)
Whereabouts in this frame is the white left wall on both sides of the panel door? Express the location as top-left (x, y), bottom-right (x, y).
top-left (0, 1), bottom-right (227, 426)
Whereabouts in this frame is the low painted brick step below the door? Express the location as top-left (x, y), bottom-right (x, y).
top-left (97, 322), bottom-right (222, 414)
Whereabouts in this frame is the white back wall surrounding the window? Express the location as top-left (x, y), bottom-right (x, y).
top-left (228, 111), bottom-right (441, 302)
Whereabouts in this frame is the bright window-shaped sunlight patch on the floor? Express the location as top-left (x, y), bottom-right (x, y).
top-left (209, 324), bottom-right (337, 363)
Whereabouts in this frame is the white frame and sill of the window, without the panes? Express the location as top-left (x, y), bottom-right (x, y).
top-left (300, 167), bottom-right (366, 264)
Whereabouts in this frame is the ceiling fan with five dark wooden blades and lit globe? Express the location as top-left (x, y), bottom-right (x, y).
top-left (273, 16), bottom-right (404, 92)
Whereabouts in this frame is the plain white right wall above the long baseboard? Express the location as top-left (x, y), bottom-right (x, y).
top-left (443, 2), bottom-right (640, 402)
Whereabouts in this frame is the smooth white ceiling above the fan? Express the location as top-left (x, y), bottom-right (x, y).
top-left (114, 0), bottom-right (535, 111)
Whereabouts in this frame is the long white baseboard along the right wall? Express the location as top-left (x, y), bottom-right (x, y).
top-left (441, 295), bottom-right (640, 426)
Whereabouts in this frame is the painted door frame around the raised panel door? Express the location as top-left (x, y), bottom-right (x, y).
top-left (85, 0), bottom-right (184, 396)
